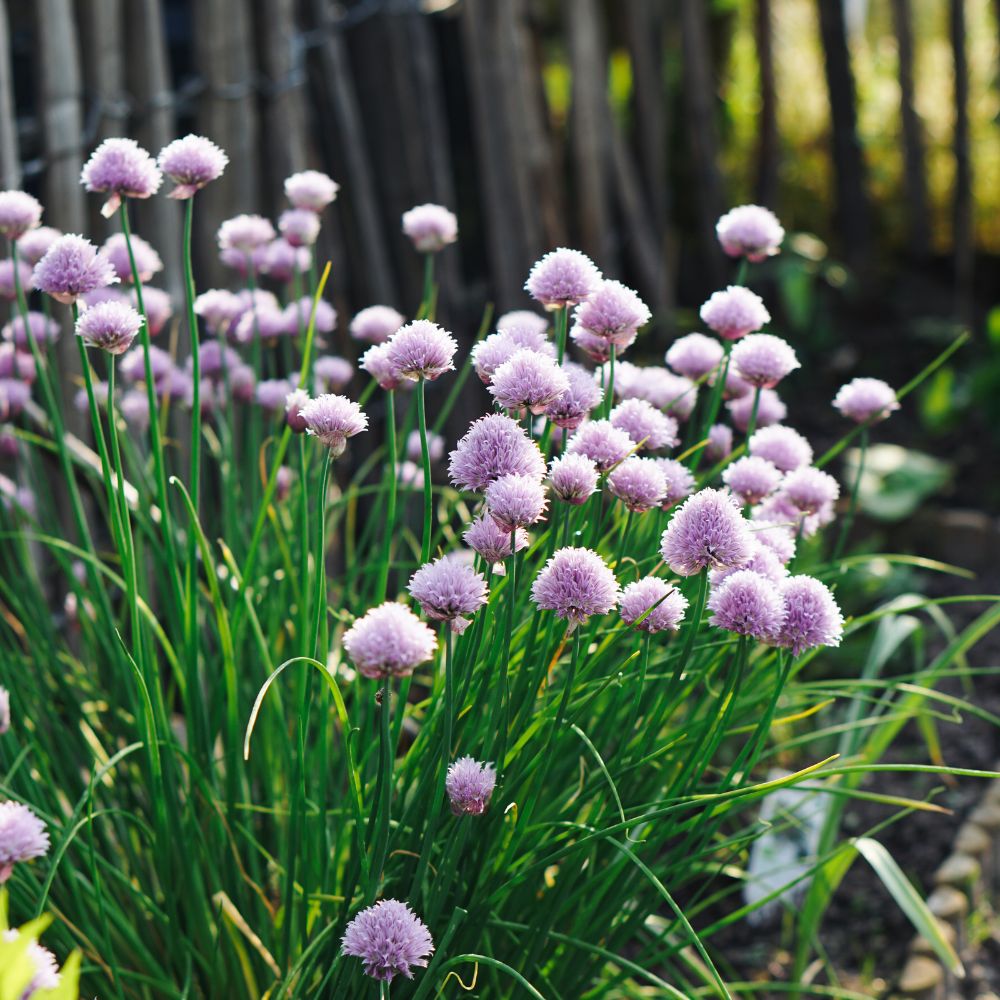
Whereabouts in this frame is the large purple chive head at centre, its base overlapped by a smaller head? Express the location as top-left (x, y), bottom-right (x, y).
top-left (448, 413), bottom-right (545, 494)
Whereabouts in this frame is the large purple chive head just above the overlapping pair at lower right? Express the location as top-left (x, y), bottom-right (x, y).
top-left (660, 489), bottom-right (753, 576)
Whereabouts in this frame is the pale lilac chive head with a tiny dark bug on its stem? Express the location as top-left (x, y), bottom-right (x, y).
top-left (342, 601), bottom-right (437, 680)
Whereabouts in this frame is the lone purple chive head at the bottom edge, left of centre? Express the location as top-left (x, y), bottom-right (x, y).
top-left (340, 900), bottom-right (434, 983)
